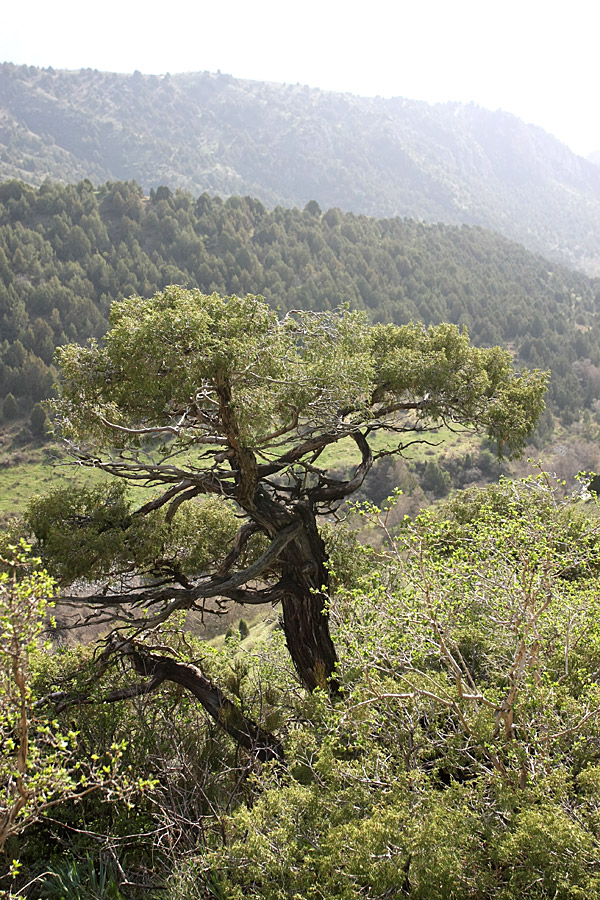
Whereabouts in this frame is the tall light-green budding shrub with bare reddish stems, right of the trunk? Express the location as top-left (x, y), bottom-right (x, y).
top-left (342, 476), bottom-right (600, 786)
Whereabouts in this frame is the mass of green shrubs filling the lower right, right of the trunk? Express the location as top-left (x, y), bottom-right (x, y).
top-left (170, 475), bottom-right (600, 900)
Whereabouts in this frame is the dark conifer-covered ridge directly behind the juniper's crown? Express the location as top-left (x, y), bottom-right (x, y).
top-left (0, 181), bottom-right (600, 422)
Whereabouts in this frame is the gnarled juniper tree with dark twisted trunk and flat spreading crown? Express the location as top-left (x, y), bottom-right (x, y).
top-left (29, 287), bottom-right (545, 756)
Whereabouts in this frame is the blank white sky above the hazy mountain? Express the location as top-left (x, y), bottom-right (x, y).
top-left (0, 0), bottom-right (600, 156)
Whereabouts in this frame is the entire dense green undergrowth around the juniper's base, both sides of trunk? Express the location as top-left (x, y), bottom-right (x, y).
top-left (2, 474), bottom-right (600, 900)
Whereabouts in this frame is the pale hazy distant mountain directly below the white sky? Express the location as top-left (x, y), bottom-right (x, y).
top-left (0, 63), bottom-right (600, 273)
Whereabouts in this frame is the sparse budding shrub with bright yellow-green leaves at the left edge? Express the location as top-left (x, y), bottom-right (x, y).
top-left (0, 544), bottom-right (134, 854)
